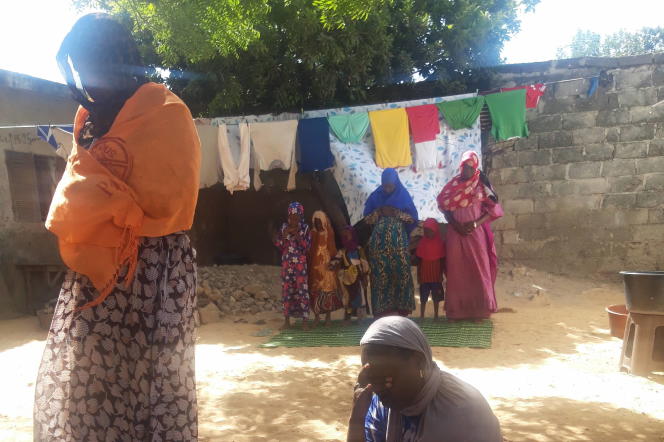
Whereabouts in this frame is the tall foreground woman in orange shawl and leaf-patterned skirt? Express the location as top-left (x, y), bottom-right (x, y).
top-left (34, 14), bottom-right (200, 441)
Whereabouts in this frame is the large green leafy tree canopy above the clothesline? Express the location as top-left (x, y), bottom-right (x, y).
top-left (78, 0), bottom-right (539, 115)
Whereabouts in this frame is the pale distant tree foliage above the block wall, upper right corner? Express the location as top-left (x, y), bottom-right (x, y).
top-left (558, 27), bottom-right (664, 58)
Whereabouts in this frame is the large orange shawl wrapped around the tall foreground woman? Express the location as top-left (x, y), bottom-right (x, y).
top-left (46, 83), bottom-right (200, 308)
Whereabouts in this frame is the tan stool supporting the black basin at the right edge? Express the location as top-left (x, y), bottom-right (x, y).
top-left (620, 313), bottom-right (664, 376)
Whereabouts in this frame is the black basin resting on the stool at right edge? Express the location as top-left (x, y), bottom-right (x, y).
top-left (620, 272), bottom-right (664, 315)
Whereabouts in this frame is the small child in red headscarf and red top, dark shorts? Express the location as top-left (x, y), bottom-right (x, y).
top-left (415, 218), bottom-right (445, 320)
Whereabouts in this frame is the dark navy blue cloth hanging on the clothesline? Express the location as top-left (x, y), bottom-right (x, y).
top-left (297, 117), bottom-right (334, 172)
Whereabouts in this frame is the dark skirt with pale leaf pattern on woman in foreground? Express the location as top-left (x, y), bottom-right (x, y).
top-left (34, 233), bottom-right (198, 442)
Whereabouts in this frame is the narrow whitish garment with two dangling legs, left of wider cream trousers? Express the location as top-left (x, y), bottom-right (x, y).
top-left (217, 123), bottom-right (251, 195)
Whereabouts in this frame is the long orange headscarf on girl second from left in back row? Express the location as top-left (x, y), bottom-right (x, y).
top-left (309, 210), bottom-right (337, 292)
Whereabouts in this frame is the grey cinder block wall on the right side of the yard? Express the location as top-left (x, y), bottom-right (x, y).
top-left (485, 54), bottom-right (664, 276)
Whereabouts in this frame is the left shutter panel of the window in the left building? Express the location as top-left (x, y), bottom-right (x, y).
top-left (5, 150), bottom-right (42, 222)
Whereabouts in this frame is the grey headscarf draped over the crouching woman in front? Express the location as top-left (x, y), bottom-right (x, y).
top-left (360, 316), bottom-right (503, 442)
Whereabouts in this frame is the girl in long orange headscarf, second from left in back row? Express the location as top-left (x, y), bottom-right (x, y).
top-left (309, 210), bottom-right (343, 326)
